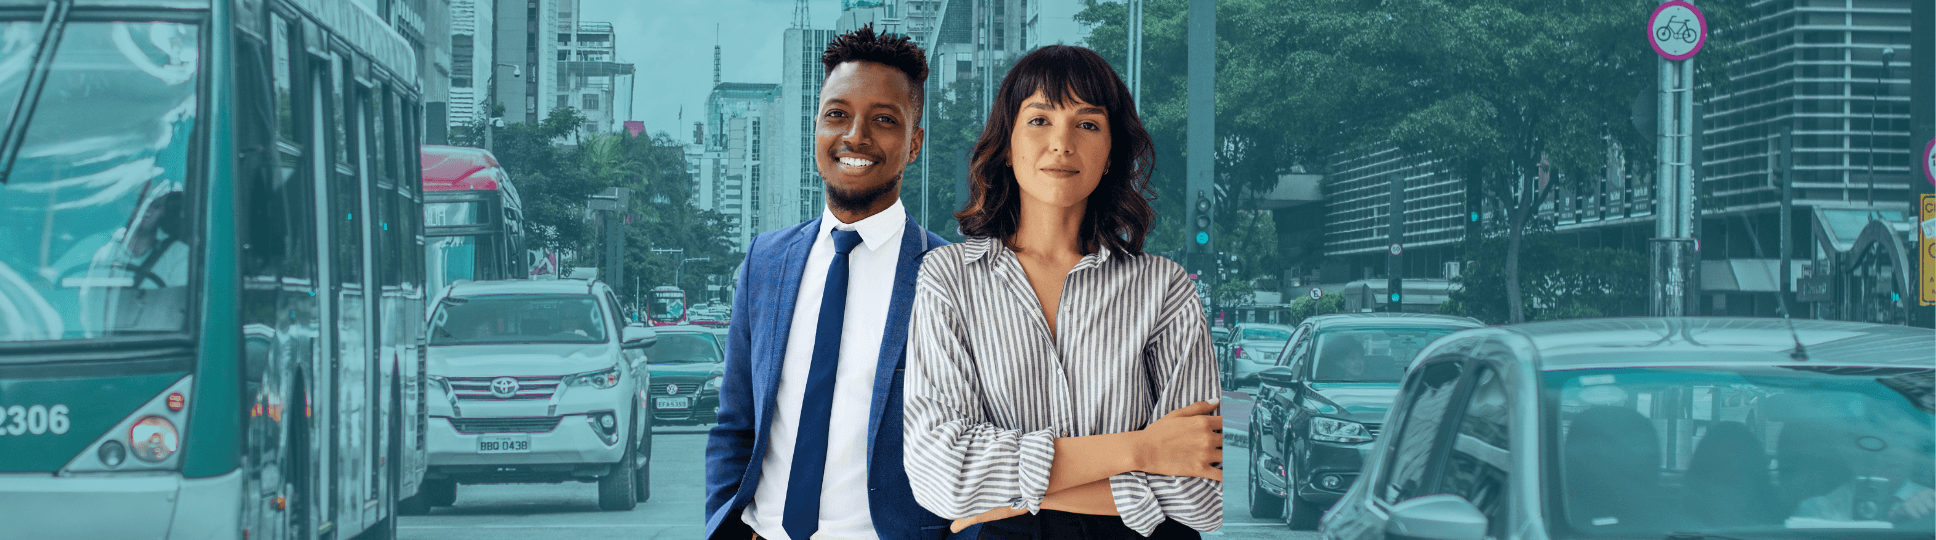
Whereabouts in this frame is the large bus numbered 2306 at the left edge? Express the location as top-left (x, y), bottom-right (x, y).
top-left (0, 0), bottom-right (426, 538)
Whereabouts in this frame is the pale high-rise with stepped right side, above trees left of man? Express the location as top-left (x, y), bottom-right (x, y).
top-left (546, 0), bottom-right (635, 134)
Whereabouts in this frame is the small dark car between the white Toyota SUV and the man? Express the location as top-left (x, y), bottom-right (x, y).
top-left (647, 325), bottom-right (726, 426)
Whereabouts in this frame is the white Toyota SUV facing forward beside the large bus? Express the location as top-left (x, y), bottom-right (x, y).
top-left (422, 279), bottom-right (658, 511)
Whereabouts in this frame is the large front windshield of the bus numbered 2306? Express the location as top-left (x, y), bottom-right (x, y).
top-left (0, 21), bottom-right (201, 343)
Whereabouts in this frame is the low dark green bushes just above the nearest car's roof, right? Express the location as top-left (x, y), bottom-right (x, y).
top-left (1438, 232), bottom-right (1649, 323)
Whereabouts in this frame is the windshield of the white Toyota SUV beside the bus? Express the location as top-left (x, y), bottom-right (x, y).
top-left (430, 294), bottom-right (606, 345)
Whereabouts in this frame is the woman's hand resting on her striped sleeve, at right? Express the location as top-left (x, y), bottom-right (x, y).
top-left (1134, 401), bottom-right (1224, 482)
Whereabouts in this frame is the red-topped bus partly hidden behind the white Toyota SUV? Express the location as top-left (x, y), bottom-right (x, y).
top-left (422, 145), bottom-right (530, 292)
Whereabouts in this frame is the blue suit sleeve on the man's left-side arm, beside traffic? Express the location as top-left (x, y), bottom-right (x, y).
top-left (707, 238), bottom-right (759, 521)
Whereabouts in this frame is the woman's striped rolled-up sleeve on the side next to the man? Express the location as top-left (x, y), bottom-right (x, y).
top-left (904, 263), bottom-right (1055, 519)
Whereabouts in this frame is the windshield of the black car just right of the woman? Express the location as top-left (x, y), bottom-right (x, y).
top-left (1311, 329), bottom-right (1458, 383)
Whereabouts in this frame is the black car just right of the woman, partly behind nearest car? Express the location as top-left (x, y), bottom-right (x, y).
top-left (1247, 314), bottom-right (1485, 530)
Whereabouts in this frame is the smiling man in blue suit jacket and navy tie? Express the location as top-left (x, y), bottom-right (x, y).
top-left (707, 25), bottom-right (972, 540)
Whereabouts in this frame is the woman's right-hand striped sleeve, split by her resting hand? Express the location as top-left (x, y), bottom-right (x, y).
top-left (1109, 265), bottom-right (1224, 536)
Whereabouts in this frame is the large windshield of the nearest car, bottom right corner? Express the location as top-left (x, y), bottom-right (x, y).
top-left (1545, 366), bottom-right (1936, 538)
